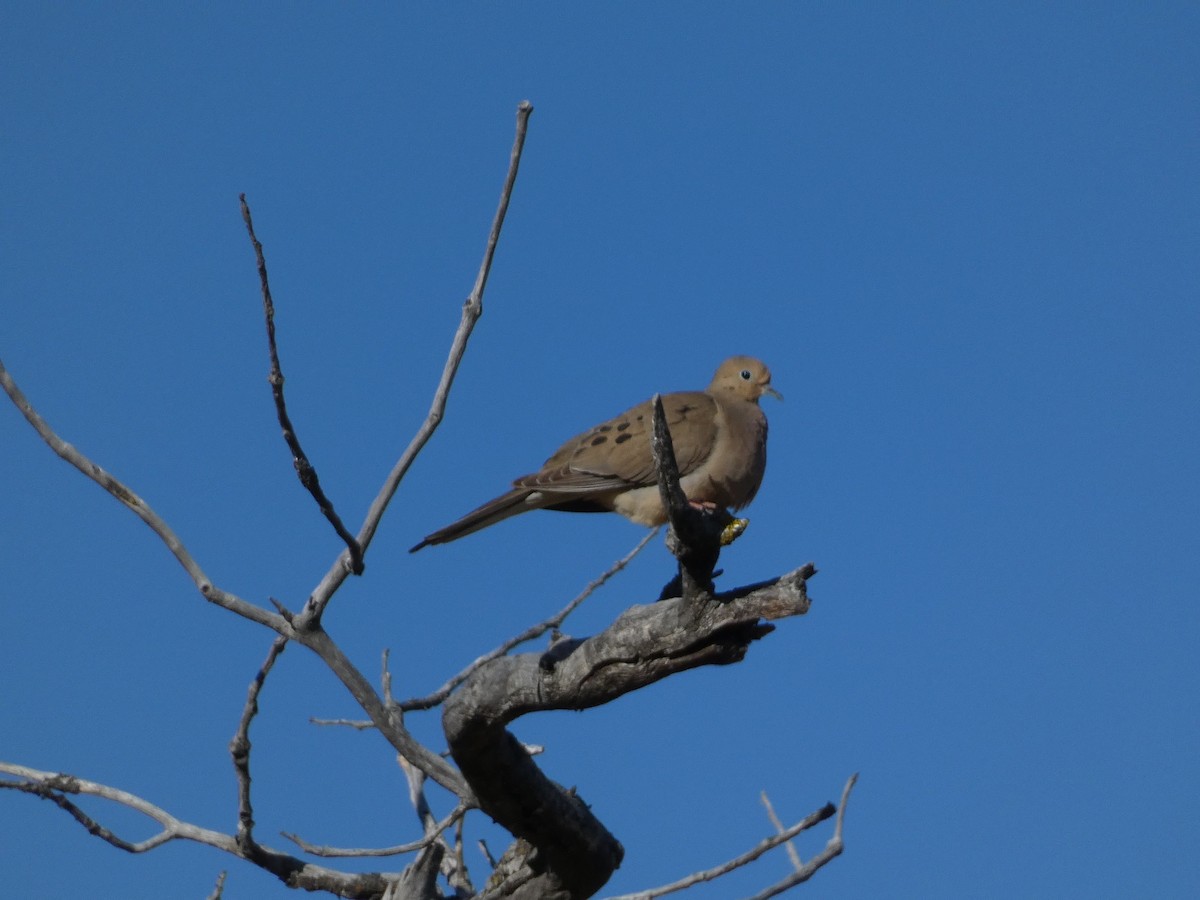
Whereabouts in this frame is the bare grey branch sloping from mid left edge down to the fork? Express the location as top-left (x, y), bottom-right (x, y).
top-left (0, 361), bottom-right (279, 634)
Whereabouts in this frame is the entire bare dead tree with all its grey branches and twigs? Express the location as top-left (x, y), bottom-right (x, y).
top-left (0, 102), bottom-right (854, 900)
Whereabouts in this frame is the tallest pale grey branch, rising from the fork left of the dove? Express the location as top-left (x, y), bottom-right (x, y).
top-left (305, 101), bottom-right (533, 618)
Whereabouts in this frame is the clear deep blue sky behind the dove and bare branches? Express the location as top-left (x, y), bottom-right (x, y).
top-left (0, 2), bottom-right (1200, 900)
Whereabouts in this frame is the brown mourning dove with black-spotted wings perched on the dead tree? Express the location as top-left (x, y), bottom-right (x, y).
top-left (409, 356), bottom-right (782, 553)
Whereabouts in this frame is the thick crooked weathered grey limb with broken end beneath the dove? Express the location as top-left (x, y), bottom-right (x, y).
top-left (442, 564), bottom-right (816, 898)
